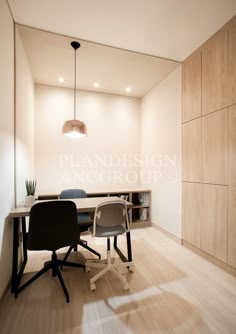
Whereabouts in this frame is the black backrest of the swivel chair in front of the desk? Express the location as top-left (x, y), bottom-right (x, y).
top-left (27, 200), bottom-right (78, 251)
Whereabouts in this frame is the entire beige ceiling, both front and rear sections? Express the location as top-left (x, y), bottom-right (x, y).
top-left (8, 0), bottom-right (236, 97)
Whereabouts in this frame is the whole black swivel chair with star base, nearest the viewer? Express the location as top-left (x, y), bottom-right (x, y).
top-left (15, 200), bottom-right (85, 303)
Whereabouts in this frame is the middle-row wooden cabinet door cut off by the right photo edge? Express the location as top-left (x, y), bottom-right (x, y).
top-left (229, 105), bottom-right (236, 187)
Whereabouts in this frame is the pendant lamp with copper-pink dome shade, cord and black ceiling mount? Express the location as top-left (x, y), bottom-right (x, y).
top-left (62, 41), bottom-right (87, 138)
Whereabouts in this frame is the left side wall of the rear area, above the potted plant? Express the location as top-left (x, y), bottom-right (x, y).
top-left (15, 28), bottom-right (34, 204)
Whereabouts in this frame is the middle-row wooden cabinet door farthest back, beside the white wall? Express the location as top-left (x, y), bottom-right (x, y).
top-left (182, 118), bottom-right (202, 182)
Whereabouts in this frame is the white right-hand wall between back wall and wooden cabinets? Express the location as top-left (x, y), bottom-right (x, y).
top-left (141, 67), bottom-right (181, 238)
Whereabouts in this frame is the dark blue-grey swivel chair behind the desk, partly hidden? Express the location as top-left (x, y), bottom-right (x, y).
top-left (59, 189), bottom-right (101, 261)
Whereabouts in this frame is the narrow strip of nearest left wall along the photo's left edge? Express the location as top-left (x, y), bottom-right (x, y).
top-left (0, 0), bottom-right (14, 296)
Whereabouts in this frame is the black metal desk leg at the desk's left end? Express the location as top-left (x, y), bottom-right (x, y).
top-left (11, 217), bottom-right (28, 292)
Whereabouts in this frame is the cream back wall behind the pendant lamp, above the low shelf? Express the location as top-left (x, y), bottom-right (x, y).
top-left (35, 85), bottom-right (140, 194)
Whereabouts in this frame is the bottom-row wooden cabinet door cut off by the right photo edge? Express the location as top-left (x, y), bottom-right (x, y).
top-left (228, 187), bottom-right (236, 268)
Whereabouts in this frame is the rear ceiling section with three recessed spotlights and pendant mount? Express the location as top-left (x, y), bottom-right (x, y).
top-left (17, 25), bottom-right (179, 97)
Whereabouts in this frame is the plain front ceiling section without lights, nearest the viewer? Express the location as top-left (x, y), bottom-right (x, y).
top-left (8, 0), bottom-right (236, 61)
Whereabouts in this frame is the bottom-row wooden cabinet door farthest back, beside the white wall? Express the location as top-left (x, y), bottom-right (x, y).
top-left (182, 182), bottom-right (201, 248)
